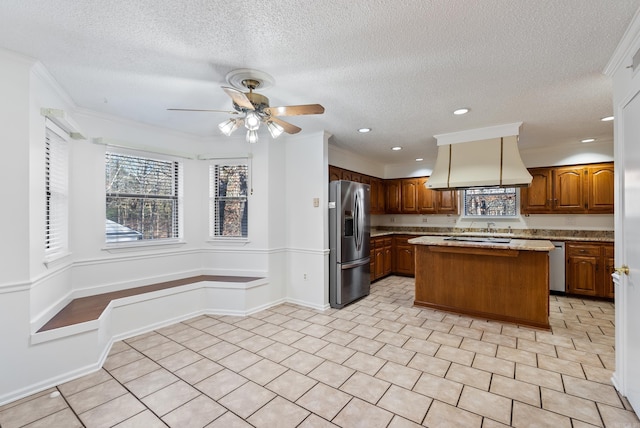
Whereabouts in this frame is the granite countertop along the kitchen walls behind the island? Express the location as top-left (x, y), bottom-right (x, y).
top-left (371, 227), bottom-right (614, 242)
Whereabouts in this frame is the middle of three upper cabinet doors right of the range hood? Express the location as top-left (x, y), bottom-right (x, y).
top-left (553, 167), bottom-right (587, 213)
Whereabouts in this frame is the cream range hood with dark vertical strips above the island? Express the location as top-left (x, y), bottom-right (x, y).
top-left (426, 122), bottom-right (533, 189)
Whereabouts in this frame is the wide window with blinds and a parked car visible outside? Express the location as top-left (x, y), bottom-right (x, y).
top-left (105, 152), bottom-right (181, 243)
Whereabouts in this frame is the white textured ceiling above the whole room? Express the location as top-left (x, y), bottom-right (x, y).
top-left (0, 0), bottom-right (640, 165)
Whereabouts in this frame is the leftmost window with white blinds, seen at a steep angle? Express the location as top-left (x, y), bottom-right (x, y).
top-left (45, 121), bottom-right (69, 260)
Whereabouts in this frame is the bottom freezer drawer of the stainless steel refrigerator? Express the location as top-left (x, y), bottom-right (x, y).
top-left (329, 257), bottom-right (371, 308)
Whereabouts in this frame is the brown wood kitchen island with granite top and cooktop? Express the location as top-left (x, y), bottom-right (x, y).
top-left (409, 236), bottom-right (554, 329)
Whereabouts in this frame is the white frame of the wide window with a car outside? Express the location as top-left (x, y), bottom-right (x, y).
top-left (104, 146), bottom-right (184, 249)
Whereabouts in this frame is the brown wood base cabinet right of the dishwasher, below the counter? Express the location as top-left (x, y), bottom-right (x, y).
top-left (565, 242), bottom-right (614, 298)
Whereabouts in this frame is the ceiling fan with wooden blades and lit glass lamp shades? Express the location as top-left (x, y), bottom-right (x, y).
top-left (167, 69), bottom-right (324, 143)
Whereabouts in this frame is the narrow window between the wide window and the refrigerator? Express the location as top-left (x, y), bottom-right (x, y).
top-left (209, 161), bottom-right (248, 238)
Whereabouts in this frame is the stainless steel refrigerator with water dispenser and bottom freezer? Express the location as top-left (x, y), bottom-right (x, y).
top-left (329, 180), bottom-right (371, 308)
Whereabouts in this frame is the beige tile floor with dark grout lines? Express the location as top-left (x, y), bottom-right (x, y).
top-left (0, 277), bottom-right (640, 428)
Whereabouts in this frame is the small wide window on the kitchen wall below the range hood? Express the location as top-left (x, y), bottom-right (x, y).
top-left (464, 187), bottom-right (518, 217)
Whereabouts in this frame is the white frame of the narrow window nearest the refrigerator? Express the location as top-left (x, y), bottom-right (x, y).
top-left (208, 157), bottom-right (251, 243)
